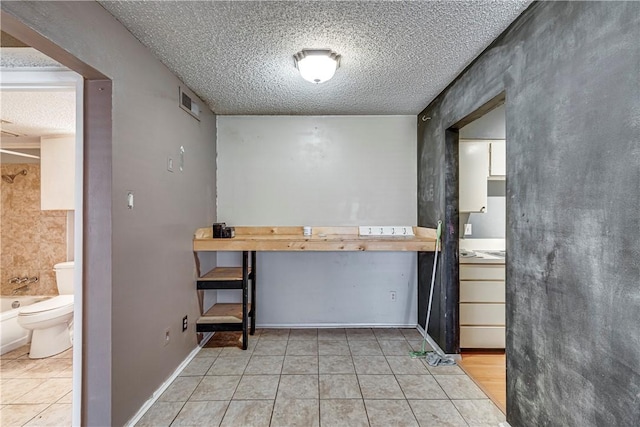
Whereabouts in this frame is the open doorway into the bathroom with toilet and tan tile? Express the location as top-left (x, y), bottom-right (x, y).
top-left (0, 51), bottom-right (84, 423)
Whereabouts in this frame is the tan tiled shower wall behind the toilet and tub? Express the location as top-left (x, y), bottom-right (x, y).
top-left (0, 164), bottom-right (67, 296)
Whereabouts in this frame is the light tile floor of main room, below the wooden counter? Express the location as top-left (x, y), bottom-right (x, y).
top-left (137, 329), bottom-right (505, 427)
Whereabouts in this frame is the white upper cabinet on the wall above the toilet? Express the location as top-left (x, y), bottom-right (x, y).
top-left (40, 135), bottom-right (76, 211)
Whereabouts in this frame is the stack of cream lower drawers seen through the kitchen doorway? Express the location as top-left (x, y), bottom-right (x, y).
top-left (459, 264), bottom-right (505, 348)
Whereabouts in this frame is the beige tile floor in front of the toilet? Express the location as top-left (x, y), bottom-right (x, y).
top-left (0, 345), bottom-right (72, 427)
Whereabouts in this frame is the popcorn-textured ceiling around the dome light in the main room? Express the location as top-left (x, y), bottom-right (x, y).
top-left (100, 0), bottom-right (530, 115)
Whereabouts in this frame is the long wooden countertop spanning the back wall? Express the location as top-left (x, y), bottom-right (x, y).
top-left (193, 227), bottom-right (436, 252)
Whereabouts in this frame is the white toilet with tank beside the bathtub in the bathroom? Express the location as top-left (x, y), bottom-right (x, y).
top-left (18, 261), bottom-right (74, 359)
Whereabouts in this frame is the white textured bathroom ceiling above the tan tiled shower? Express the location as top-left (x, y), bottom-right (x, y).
top-left (0, 91), bottom-right (76, 138)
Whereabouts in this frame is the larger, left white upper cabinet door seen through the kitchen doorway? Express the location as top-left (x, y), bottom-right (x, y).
top-left (459, 141), bottom-right (489, 212)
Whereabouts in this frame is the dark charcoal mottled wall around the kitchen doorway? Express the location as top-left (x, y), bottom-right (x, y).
top-left (418, 2), bottom-right (640, 427)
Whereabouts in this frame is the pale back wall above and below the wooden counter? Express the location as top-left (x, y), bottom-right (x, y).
top-left (217, 116), bottom-right (417, 326)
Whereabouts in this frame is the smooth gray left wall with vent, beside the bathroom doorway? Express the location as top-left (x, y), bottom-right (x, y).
top-left (2, 1), bottom-right (216, 426)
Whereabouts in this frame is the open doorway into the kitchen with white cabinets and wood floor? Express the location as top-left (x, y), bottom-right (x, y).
top-left (447, 94), bottom-right (507, 413)
